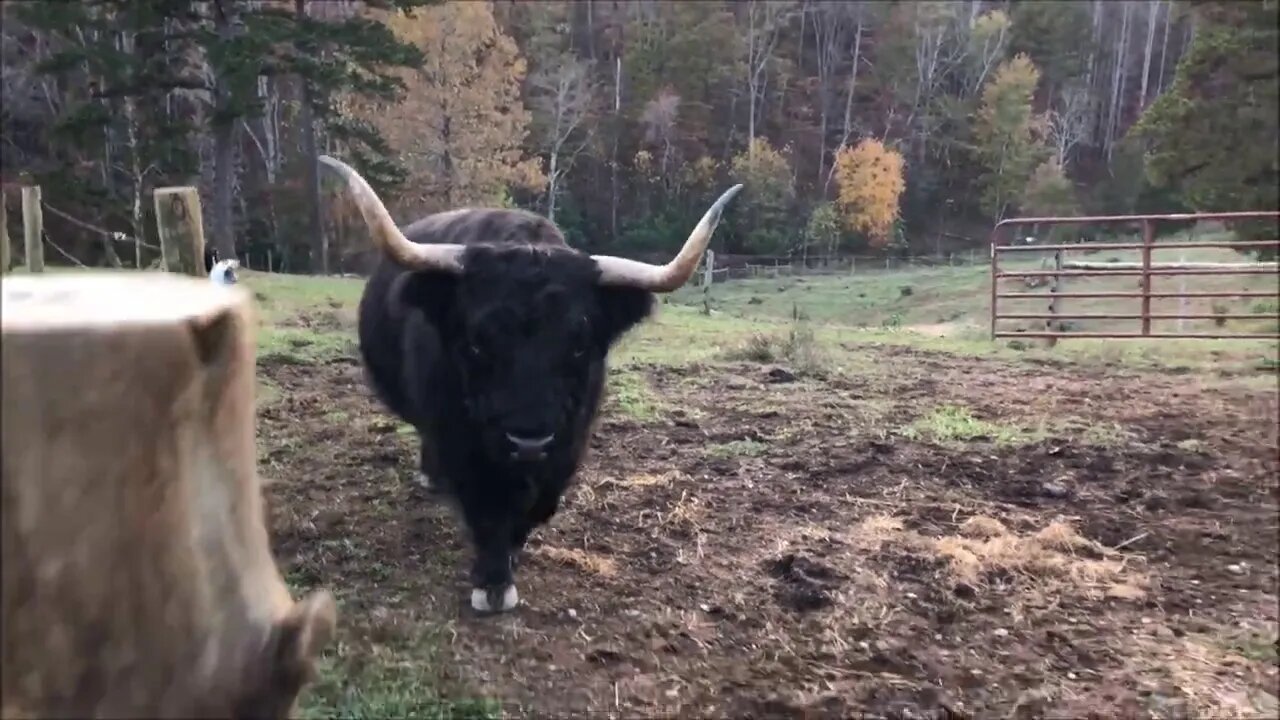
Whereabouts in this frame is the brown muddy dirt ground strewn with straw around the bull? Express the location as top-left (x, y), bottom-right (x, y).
top-left (259, 347), bottom-right (1280, 717)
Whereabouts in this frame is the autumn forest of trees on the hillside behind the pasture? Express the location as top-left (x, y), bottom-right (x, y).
top-left (0, 0), bottom-right (1280, 272)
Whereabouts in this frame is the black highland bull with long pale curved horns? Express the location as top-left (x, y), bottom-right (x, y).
top-left (314, 156), bottom-right (742, 612)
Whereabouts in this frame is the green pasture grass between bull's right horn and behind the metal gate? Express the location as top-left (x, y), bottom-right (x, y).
top-left (663, 232), bottom-right (1280, 373)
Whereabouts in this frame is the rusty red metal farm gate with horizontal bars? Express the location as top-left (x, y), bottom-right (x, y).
top-left (991, 211), bottom-right (1280, 342)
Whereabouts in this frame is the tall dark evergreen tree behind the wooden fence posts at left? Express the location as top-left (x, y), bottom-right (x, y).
top-left (18, 0), bottom-right (428, 263)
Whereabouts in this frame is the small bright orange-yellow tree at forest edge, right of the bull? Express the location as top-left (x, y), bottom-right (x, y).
top-left (836, 138), bottom-right (906, 247)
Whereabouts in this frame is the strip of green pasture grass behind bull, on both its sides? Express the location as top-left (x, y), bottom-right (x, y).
top-left (10, 258), bottom-right (1280, 371)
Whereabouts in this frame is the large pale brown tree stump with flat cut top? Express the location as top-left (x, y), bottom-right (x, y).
top-left (0, 273), bottom-right (335, 717)
